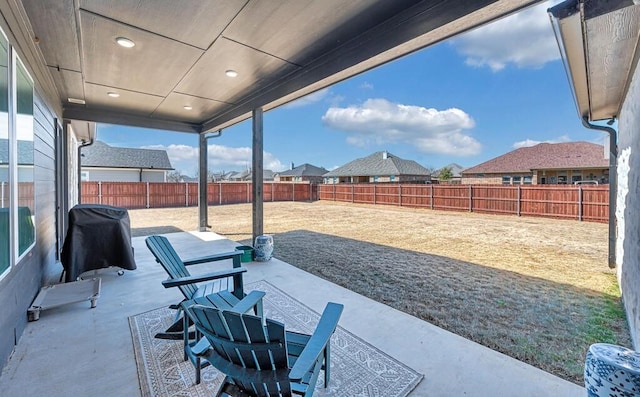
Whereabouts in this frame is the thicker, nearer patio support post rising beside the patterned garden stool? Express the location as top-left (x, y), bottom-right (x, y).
top-left (251, 108), bottom-right (264, 241)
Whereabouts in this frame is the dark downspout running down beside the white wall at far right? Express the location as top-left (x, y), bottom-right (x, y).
top-left (582, 116), bottom-right (618, 269)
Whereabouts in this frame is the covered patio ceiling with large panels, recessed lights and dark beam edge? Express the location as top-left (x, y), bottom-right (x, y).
top-left (16, 0), bottom-right (535, 133)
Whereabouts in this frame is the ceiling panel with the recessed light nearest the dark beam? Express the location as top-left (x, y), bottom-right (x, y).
top-left (175, 38), bottom-right (298, 103)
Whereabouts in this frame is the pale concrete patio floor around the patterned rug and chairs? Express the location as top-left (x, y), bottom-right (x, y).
top-left (0, 232), bottom-right (586, 397)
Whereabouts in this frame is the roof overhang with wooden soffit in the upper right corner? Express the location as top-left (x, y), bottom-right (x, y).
top-left (548, 0), bottom-right (640, 121)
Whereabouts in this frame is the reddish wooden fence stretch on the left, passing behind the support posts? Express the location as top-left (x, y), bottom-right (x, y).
top-left (81, 182), bottom-right (317, 209)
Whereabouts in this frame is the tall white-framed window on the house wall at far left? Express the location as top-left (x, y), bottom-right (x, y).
top-left (0, 31), bottom-right (36, 277)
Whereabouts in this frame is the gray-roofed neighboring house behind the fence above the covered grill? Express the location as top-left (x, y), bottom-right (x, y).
top-left (80, 141), bottom-right (173, 182)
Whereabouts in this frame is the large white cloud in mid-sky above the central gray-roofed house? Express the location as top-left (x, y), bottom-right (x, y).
top-left (322, 99), bottom-right (481, 156)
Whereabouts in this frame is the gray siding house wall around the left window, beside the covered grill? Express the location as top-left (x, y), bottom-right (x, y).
top-left (0, 90), bottom-right (57, 366)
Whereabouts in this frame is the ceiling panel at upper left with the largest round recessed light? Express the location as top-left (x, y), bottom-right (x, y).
top-left (81, 12), bottom-right (203, 96)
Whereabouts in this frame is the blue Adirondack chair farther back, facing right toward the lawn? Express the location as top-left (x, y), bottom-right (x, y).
top-left (145, 236), bottom-right (264, 344)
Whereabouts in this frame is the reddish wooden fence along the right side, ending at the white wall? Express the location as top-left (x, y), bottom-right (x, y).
top-left (318, 183), bottom-right (609, 223)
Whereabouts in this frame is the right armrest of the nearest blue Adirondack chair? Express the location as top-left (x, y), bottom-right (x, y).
top-left (289, 302), bottom-right (344, 382)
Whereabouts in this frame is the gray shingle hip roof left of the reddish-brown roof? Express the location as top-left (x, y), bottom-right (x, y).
top-left (324, 152), bottom-right (430, 177)
